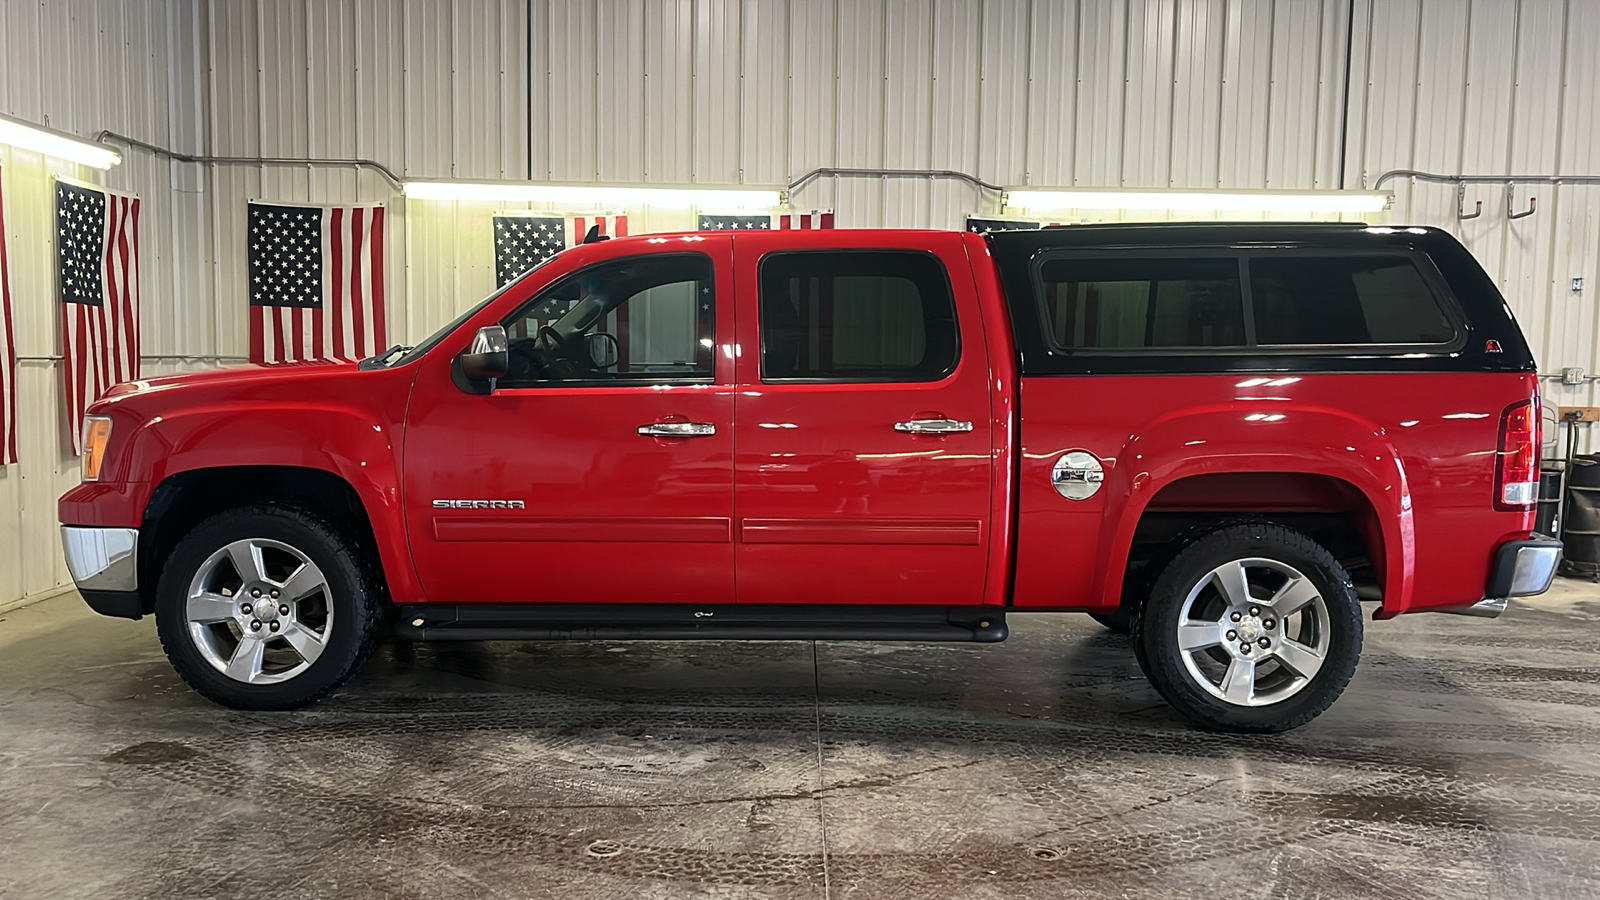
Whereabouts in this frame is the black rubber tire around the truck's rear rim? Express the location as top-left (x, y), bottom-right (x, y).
top-left (1133, 522), bottom-right (1362, 733)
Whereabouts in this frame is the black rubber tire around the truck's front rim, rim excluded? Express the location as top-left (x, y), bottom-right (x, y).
top-left (155, 504), bottom-right (382, 709)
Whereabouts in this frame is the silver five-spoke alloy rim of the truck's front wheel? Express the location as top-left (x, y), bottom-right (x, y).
top-left (184, 538), bottom-right (333, 684)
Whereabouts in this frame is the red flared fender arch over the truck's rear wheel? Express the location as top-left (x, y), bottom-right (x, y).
top-left (1094, 404), bottom-right (1416, 615)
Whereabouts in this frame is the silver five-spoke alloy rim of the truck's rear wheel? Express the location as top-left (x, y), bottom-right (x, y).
top-left (1178, 557), bottom-right (1331, 706)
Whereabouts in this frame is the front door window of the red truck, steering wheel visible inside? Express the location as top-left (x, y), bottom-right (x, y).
top-left (501, 255), bottom-right (715, 386)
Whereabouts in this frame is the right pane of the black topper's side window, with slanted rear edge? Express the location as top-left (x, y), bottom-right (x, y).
top-left (1250, 256), bottom-right (1456, 344)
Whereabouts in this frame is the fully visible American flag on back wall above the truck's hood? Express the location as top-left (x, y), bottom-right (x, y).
top-left (248, 203), bottom-right (389, 365)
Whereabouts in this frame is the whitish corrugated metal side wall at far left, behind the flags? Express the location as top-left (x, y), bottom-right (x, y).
top-left (0, 0), bottom-right (213, 609)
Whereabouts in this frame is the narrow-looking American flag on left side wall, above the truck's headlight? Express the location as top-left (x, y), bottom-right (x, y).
top-left (56, 179), bottom-right (139, 453)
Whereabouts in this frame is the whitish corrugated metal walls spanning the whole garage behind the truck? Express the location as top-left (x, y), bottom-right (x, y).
top-left (0, 0), bottom-right (1600, 602)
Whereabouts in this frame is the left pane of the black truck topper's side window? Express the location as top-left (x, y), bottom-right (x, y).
top-left (1040, 256), bottom-right (1245, 348)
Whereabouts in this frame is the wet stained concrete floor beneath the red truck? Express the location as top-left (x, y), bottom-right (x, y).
top-left (0, 583), bottom-right (1600, 900)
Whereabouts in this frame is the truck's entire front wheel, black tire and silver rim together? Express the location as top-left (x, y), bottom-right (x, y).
top-left (155, 506), bottom-right (381, 709)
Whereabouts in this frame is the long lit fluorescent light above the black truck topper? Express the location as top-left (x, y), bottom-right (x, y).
top-left (1005, 187), bottom-right (1394, 213)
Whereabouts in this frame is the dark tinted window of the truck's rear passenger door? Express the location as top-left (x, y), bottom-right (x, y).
top-left (762, 250), bottom-right (960, 381)
